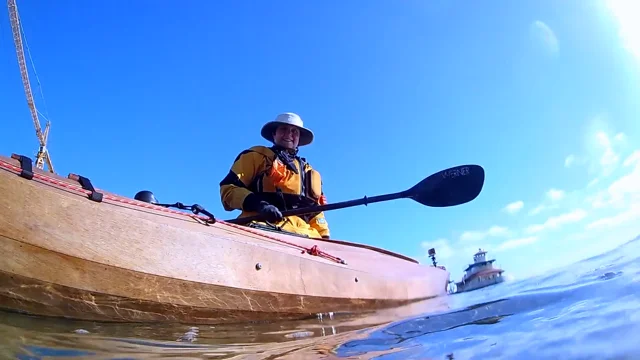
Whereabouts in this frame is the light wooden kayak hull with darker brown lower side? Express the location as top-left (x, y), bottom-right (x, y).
top-left (0, 153), bottom-right (449, 324)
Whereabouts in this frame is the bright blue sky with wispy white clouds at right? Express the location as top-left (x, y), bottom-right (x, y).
top-left (0, 0), bottom-right (640, 279)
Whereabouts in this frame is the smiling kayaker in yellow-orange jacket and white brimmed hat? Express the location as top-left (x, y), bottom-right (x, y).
top-left (220, 113), bottom-right (330, 239)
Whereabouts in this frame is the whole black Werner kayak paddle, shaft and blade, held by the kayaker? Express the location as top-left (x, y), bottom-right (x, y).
top-left (225, 165), bottom-right (484, 224)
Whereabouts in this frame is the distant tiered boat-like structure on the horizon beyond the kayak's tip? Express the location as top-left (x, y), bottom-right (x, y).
top-left (449, 249), bottom-right (504, 293)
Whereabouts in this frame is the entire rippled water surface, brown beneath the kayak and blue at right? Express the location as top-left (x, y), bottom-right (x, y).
top-left (0, 237), bottom-right (640, 360)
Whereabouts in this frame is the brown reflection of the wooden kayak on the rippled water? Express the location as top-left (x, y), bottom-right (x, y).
top-left (0, 298), bottom-right (450, 359)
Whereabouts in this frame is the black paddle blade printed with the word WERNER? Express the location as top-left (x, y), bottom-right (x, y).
top-left (407, 165), bottom-right (484, 207)
